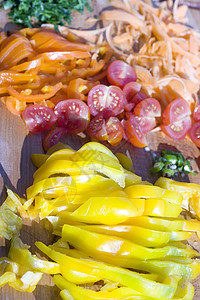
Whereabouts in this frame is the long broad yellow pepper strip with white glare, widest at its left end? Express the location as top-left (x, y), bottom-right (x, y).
top-left (62, 224), bottom-right (198, 263)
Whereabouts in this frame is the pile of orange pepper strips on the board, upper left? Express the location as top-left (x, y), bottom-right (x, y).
top-left (0, 28), bottom-right (112, 115)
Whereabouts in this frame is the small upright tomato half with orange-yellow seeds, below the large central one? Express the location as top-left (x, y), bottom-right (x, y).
top-left (106, 117), bottom-right (123, 146)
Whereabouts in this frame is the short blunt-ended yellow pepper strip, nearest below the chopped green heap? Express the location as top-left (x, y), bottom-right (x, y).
top-left (124, 184), bottom-right (183, 205)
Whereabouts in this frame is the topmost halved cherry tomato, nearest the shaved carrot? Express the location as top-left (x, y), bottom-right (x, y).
top-left (107, 60), bottom-right (137, 87)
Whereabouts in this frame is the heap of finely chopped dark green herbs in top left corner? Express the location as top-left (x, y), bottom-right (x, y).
top-left (1, 0), bottom-right (92, 27)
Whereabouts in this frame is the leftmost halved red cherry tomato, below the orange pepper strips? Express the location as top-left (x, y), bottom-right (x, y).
top-left (22, 104), bottom-right (57, 133)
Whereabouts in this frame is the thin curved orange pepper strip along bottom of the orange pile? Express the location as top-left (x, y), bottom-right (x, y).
top-left (8, 82), bottom-right (62, 102)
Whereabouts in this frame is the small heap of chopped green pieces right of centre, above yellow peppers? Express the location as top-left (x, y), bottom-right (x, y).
top-left (150, 150), bottom-right (198, 177)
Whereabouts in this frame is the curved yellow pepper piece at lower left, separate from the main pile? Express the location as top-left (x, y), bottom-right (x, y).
top-left (8, 237), bottom-right (60, 274)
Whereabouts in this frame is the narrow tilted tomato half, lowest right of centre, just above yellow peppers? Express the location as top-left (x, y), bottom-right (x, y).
top-left (125, 115), bottom-right (147, 148)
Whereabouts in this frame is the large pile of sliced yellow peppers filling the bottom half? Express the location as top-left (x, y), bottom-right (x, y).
top-left (0, 142), bottom-right (200, 300)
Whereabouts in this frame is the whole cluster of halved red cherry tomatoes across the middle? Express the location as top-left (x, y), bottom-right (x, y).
top-left (22, 60), bottom-right (200, 149)
